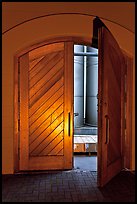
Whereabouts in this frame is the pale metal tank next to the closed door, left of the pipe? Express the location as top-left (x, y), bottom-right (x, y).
top-left (74, 45), bottom-right (84, 128)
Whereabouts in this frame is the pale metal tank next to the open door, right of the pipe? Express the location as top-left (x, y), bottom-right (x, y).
top-left (85, 47), bottom-right (98, 126)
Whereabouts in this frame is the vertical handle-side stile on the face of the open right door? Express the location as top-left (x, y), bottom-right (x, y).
top-left (100, 27), bottom-right (110, 186)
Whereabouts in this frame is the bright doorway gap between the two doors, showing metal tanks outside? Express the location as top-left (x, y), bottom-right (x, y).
top-left (73, 44), bottom-right (98, 171)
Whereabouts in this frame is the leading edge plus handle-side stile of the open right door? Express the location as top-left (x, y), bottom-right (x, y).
top-left (97, 27), bottom-right (108, 187)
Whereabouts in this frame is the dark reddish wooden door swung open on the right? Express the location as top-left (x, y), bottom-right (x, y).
top-left (98, 27), bottom-right (125, 187)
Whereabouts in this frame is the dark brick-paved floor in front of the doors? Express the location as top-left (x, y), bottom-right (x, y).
top-left (2, 169), bottom-right (135, 202)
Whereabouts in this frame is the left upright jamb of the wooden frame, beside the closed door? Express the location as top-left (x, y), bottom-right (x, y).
top-left (13, 58), bottom-right (19, 172)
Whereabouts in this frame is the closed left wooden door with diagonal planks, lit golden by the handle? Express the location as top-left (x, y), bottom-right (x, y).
top-left (19, 42), bottom-right (73, 170)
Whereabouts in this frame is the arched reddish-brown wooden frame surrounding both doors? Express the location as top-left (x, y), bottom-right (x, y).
top-left (13, 36), bottom-right (133, 173)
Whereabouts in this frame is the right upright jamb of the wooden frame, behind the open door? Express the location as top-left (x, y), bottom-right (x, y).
top-left (125, 56), bottom-right (133, 169)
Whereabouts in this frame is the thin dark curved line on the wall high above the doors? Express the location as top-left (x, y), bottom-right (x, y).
top-left (2, 12), bottom-right (134, 35)
